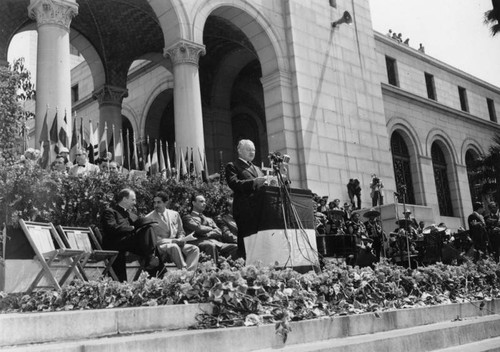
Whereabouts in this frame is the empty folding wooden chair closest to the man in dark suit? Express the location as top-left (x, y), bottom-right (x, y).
top-left (56, 225), bottom-right (118, 281)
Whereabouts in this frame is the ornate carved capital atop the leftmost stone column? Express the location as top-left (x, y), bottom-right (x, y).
top-left (28, 0), bottom-right (78, 31)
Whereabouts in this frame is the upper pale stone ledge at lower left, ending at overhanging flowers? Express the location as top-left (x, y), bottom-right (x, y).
top-left (0, 304), bottom-right (211, 346)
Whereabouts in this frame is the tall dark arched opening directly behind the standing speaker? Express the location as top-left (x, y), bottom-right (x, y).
top-left (200, 11), bottom-right (268, 170)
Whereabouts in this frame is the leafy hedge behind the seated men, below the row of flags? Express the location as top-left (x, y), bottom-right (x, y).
top-left (0, 163), bottom-right (231, 226)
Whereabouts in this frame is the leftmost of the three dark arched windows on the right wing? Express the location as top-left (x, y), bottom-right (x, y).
top-left (391, 132), bottom-right (415, 204)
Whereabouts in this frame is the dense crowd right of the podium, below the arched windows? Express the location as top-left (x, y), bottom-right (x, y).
top-left (314, 192), bottom-right (500, 265)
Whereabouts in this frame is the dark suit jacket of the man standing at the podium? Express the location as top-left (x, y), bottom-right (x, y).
top-left (226, 159), bottom-right (264, 237)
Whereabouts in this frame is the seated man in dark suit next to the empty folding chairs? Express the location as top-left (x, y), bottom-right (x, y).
top-left (101, 188), bottom-right (160, 281)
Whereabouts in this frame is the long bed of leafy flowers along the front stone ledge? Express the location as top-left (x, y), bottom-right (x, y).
top-left (0, 260), bottom-right (500, 337)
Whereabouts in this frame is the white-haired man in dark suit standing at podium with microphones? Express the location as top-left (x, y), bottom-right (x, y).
top-left (226, 139), bottom-right (267, 258)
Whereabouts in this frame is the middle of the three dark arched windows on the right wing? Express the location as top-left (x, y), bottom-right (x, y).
top-left (431, 142), bottom-right (453, 216)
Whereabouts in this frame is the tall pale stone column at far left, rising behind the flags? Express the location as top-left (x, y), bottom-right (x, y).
top-left (28, 0), bottom-right (78, 146)
